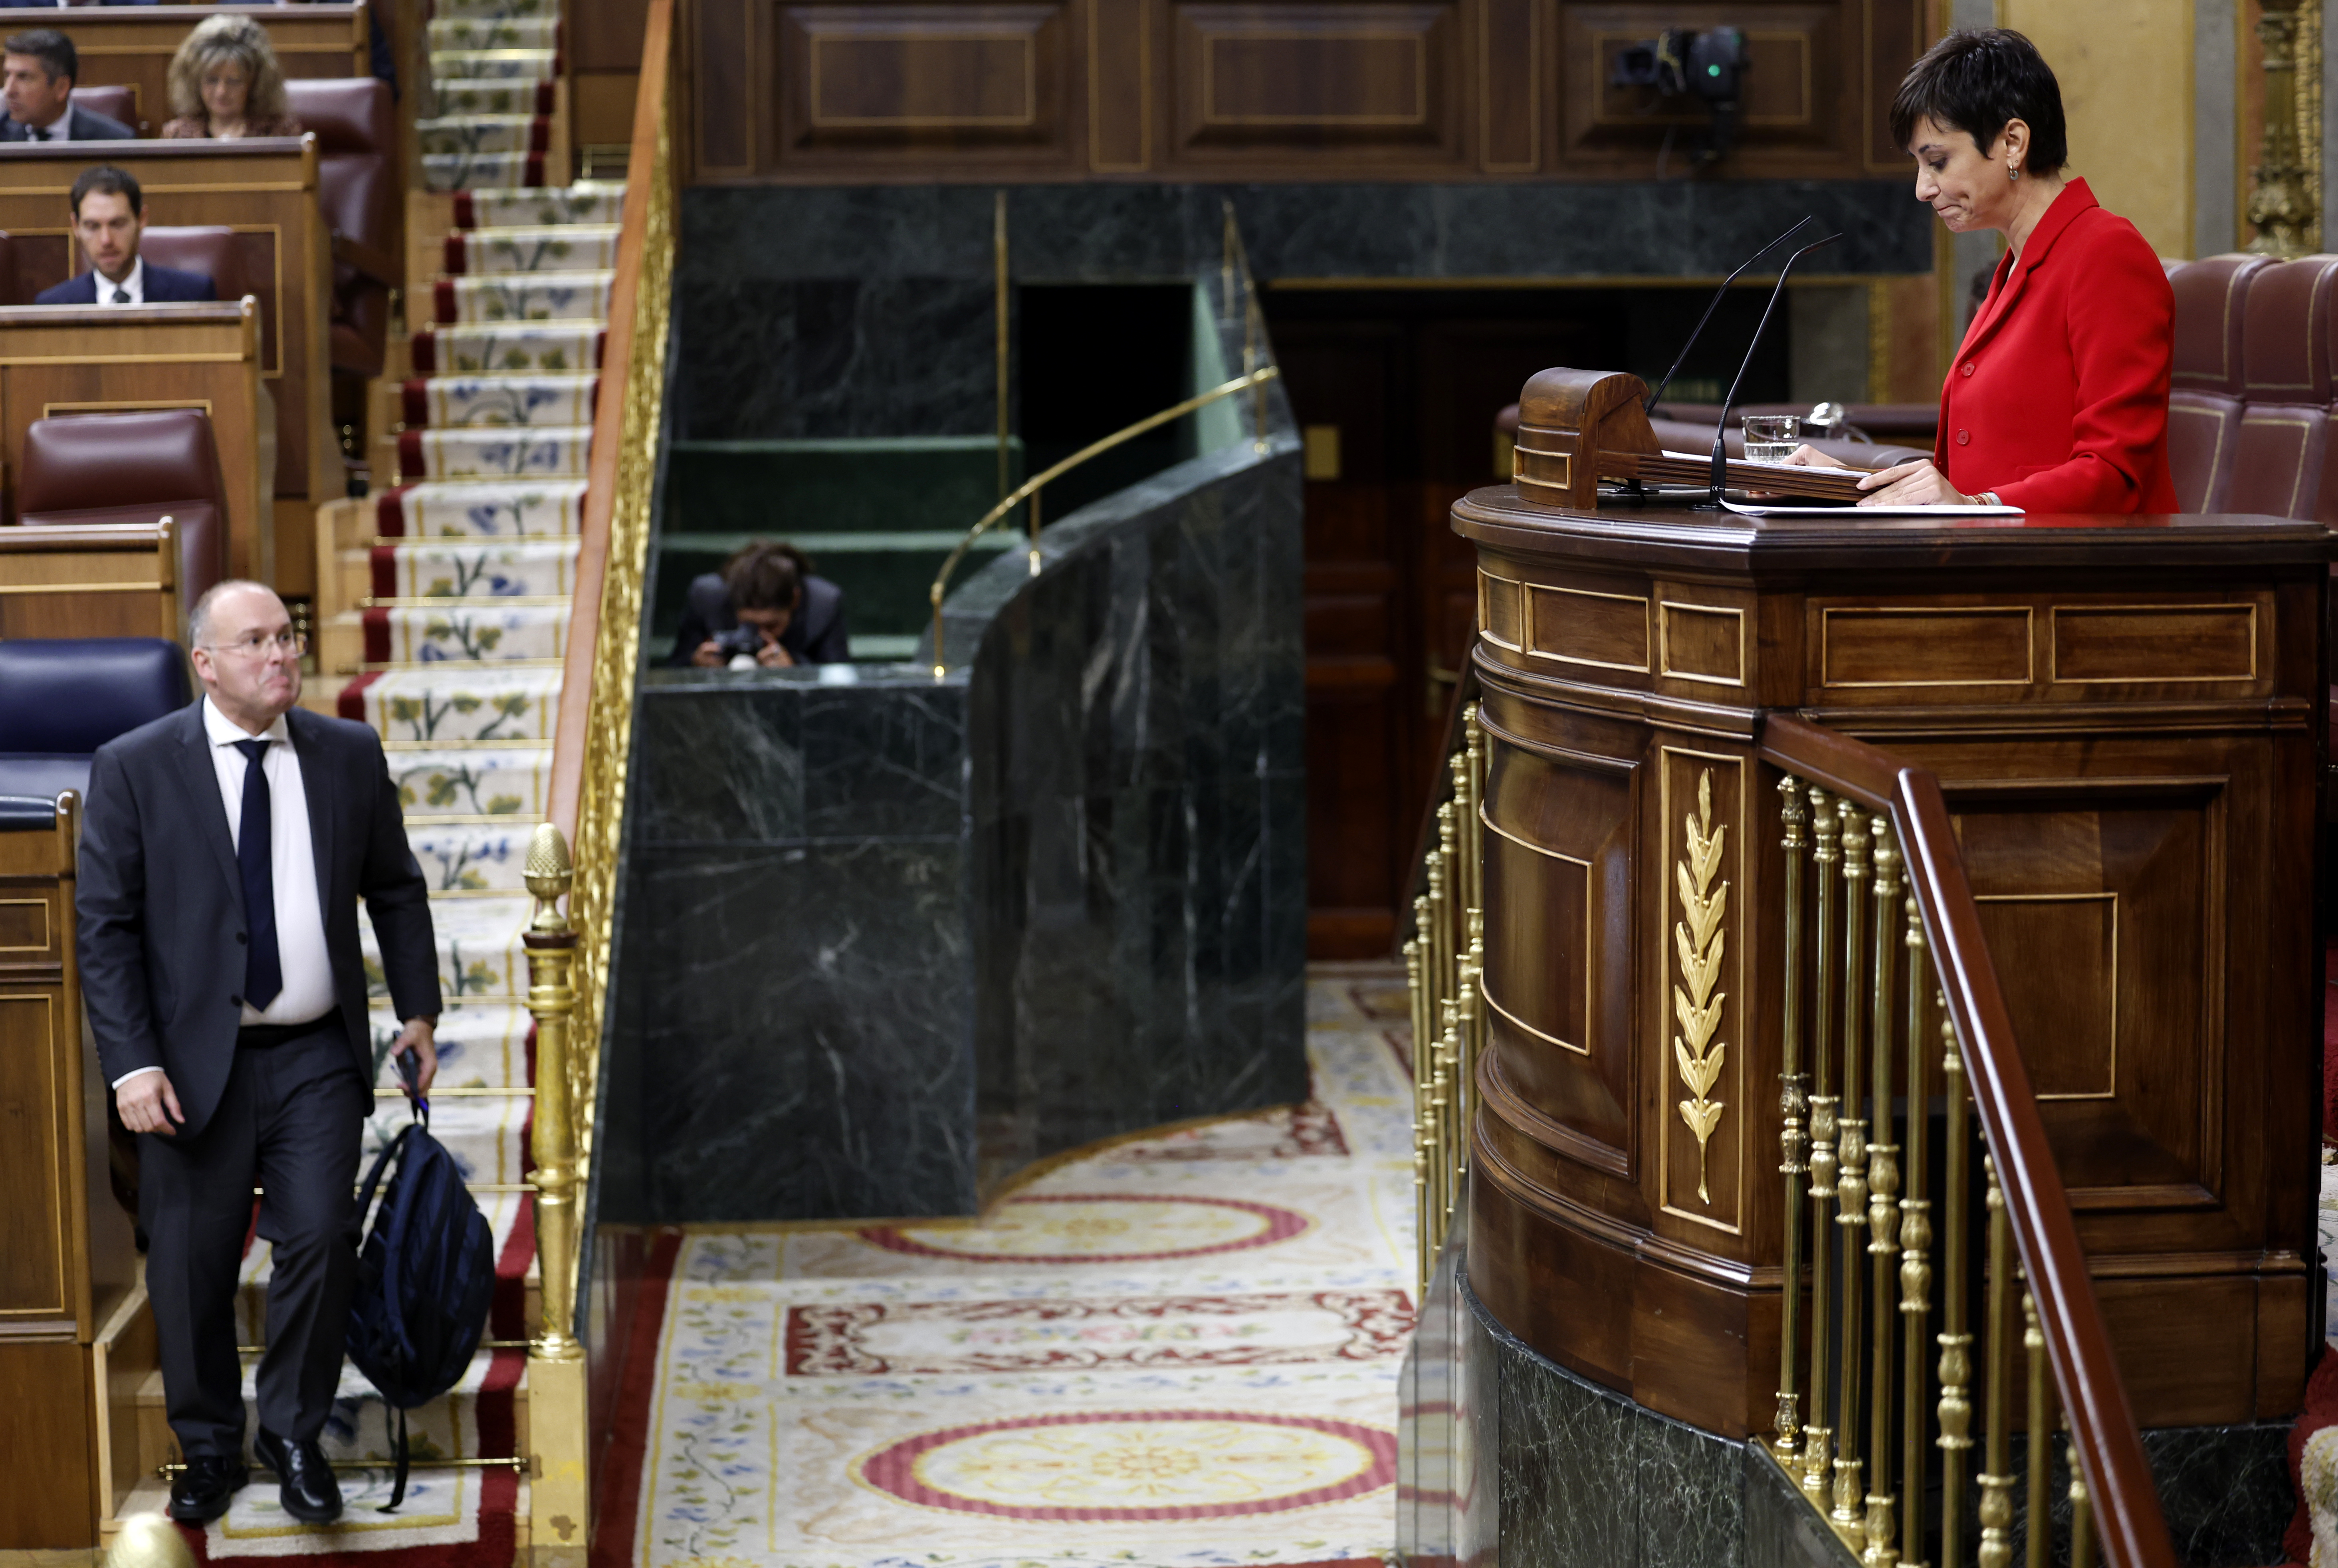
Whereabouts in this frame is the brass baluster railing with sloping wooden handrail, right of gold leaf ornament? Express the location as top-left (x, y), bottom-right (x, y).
top-left (1767, 715), bottom-right (2174, 1568)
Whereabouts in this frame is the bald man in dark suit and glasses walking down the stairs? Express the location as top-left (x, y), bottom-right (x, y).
top-left (75, 582), bottom-right (440, 1524)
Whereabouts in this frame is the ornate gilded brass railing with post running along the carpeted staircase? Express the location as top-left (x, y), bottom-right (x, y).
top-left (524, 0), bottom-right (676, 1563)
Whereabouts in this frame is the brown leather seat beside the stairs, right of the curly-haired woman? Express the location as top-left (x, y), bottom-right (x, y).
top-left (285, 77), bottom-right (398, 376)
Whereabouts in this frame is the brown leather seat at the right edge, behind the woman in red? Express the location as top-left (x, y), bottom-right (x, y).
top-left (2207, 255), bottom-right (2338, 516)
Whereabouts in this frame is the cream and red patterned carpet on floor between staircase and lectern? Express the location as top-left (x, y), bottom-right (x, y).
top-left (596, 967), bottom-right (1412, 1568)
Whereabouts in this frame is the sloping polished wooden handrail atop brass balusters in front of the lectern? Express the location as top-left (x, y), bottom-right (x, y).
top-left (1761, 713), bottom-right (2174, 1568)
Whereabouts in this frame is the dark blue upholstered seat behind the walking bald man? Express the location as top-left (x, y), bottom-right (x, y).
top-left (0, 638), bottom-right (194, 799)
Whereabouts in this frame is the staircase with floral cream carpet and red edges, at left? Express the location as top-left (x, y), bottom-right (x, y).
top-left (100, 0), bottom-right (624, 1542)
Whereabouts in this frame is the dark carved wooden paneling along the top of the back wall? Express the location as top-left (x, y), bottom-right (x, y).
top-left (685, 0), bottom-right (1924, 182)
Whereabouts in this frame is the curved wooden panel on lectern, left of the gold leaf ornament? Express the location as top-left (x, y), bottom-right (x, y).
top-left (1485, 720), bottom-right (1637, 1176)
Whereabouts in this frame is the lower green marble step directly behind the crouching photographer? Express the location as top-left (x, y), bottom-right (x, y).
top-left (650, 530), bottom-right (1024, 659)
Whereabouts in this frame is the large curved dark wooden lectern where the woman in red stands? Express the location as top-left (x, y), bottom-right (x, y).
top-left (1452, 372), bottom-right (2333, 1437)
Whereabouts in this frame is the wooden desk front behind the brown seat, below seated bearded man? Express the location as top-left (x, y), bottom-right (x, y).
top-left (0, 301), bottom-right (278, 582)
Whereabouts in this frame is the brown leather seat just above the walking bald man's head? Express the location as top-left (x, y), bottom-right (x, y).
top-left (16, 409), bottom-right (227, 605)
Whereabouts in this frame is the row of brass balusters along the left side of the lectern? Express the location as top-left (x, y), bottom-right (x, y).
top-left (1405, 704), bottom-right (1485, 1302)
